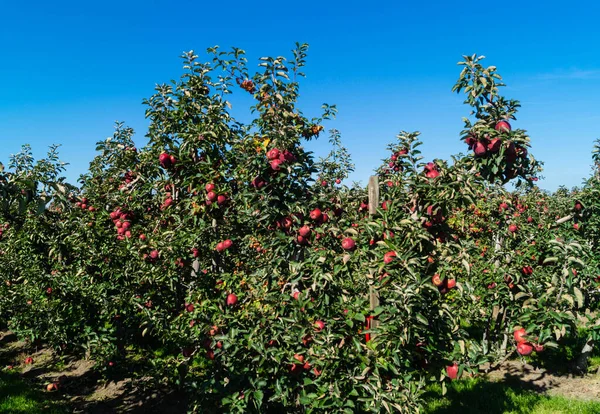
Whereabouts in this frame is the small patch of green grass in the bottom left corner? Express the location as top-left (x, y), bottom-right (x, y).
top-left (0, 372), bottom-right (68, 414)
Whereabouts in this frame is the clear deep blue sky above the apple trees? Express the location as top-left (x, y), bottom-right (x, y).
top-left (0, 0), bottom-right (600, 190)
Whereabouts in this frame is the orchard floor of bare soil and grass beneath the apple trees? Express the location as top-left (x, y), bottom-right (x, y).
top-left (0, 332), bottom-right (600, 414)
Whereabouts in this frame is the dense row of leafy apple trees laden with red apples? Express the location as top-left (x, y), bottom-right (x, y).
top-left (0, 44), bottom-right (600, 413)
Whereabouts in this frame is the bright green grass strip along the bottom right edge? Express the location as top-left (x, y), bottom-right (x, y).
top-left (424, 379), bottom-right (600, 414)
